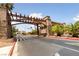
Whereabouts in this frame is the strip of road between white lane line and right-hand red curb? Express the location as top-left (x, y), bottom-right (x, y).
top-left (40, 37), bottom-right (79, 51)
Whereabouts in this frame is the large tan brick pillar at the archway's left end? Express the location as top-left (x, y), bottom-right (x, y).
top-left (0, 8), bottom-right (11, 38)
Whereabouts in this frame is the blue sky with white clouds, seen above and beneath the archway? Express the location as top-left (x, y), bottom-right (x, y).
top-left (13, 3), bottom-right (79, 32)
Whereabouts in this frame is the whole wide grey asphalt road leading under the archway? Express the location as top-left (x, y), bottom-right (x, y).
top-left (17, 35), bottom-right (79, 56)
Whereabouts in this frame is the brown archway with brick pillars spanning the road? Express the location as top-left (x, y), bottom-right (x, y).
top-left (0, 4), bottom-right (63, 38)
